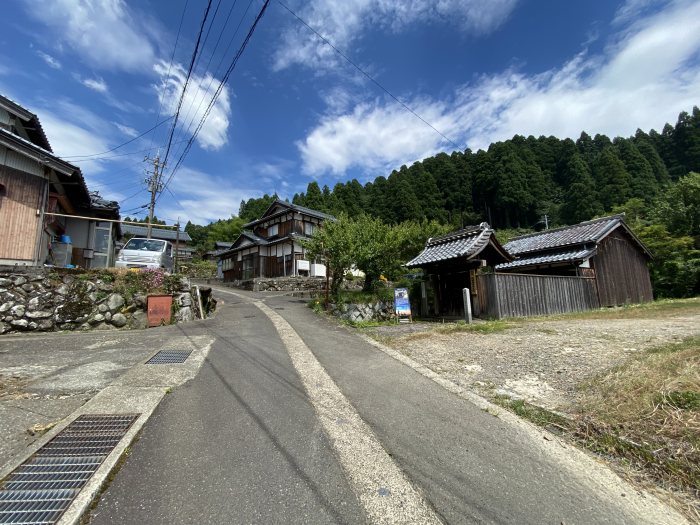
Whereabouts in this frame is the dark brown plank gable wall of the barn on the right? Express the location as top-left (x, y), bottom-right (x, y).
top-left (592, 228), bottom-right (654, 306)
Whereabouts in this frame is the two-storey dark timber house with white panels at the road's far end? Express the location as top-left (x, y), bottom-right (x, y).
top-left (219, 200), bottom-right (335, 282)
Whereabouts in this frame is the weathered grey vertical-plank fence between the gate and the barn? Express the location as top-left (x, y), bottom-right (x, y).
top-left (478, 273), bottom-right (600, 319)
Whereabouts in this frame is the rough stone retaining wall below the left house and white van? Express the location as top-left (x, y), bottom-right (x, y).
top-left (0, 266), bottom-right (193, 334)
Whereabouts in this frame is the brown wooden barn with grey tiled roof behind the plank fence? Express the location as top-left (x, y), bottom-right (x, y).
top-left (496, 215), bottom-right (653, 306)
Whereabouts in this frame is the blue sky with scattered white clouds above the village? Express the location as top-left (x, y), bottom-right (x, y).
top-left (0, 0), bottom-right (700, 224)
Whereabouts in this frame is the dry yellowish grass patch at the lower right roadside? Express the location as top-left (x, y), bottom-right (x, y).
top-left (573, 337), bottom-right (700, 521)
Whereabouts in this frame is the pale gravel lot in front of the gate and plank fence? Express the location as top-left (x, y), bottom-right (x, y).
top-left (370, 311), bottom-right (700, 412)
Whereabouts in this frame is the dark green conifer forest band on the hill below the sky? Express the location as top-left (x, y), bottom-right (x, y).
top-left (288, 107), bottom-right (700, 228)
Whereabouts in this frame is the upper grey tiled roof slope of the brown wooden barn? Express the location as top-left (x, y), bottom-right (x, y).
top-left (505, 215), bottom-right (623, 255)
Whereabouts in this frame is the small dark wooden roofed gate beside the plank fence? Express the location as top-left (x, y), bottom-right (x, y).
top-left (405, 222), bottom-right (513, 317)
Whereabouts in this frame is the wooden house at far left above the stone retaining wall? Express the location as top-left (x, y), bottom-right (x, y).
top-left (0, 95), bottom-right (119, 267)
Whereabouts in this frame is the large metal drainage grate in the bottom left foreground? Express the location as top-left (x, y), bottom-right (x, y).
top-left (0, 414), bottom-right (139, 525)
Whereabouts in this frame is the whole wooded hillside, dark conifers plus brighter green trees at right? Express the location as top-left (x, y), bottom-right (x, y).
top-left (231, 107), bottom-right (700, 297)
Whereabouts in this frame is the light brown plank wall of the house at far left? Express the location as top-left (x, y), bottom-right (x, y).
top-left (0, 166), bottom-right (46, 263)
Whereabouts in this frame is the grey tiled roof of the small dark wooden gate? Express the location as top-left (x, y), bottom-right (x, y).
top-left (405, 222), bottom-right (506, 268)
